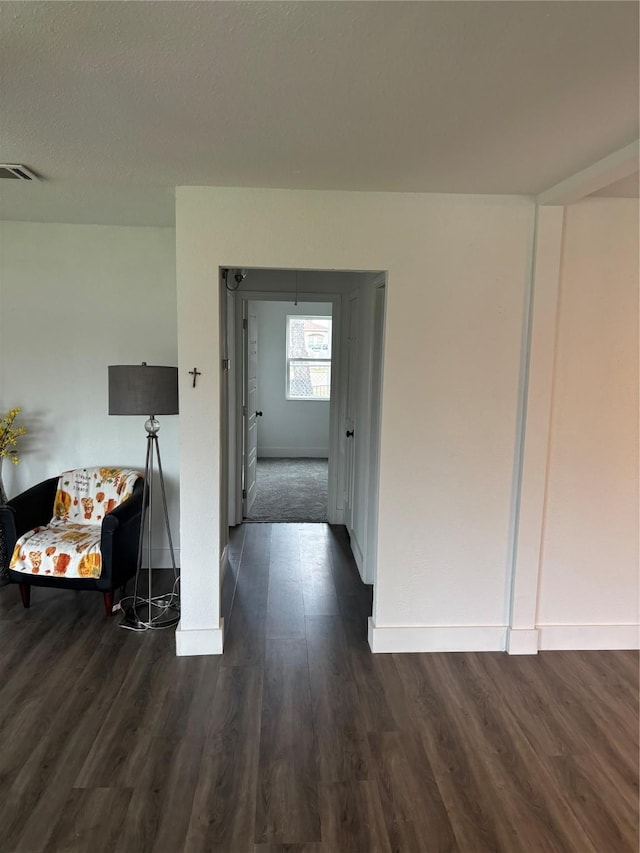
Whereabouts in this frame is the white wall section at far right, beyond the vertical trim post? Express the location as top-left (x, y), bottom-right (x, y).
top-left (538, 198), bottom-right (639, 648)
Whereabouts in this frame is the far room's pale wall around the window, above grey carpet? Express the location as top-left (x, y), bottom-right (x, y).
top-left (251, 301), bottom-right (332, 458)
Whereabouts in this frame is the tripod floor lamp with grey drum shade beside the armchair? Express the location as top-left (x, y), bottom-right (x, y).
top-left (109, 362), bottom-right (180, 631)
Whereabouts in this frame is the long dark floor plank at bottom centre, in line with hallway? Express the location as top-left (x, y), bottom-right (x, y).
top-left (255, 640), bottom-right (321, 843)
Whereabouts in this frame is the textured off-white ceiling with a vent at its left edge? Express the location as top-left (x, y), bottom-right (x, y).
top-left (0, 0), bottom-right (638, 224)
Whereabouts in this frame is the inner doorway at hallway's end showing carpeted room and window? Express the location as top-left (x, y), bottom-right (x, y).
top-left (242, 299), bottom-right (333, 522)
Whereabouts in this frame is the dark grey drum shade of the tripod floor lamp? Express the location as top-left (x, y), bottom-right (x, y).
top-left (109, 363), bottom-right (178, 417)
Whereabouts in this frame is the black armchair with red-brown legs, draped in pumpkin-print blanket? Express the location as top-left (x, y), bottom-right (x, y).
top-left (0, 468), bottom-right (144, 615)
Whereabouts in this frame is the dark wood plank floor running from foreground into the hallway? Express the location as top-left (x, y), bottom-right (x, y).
top-left (0, 524), bottom-right (638, 853)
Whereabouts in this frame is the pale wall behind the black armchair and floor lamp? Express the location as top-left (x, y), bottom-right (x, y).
top-left (0, 221), bottom-right (179, 564)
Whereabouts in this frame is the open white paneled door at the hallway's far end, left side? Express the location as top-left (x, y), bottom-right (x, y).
top-left (242, 310), bottom-right (262, 518)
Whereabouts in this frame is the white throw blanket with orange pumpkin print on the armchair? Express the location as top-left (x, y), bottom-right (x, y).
top-left (9, 468), bottom-right (142, 578)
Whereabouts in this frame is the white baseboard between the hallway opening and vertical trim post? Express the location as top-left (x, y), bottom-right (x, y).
top-left (368, 617), bottom-right (507, 653)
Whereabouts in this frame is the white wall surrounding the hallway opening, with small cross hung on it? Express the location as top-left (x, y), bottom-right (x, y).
top-left (176, 187), bottom-right (534, 654)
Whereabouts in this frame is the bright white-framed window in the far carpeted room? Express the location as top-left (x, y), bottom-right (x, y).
top-left (286, 314), bottom-right (331, 400)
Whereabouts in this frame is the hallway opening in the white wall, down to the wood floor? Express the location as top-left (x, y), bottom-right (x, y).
top-left (220, 269), bottom-right (386, 583)
